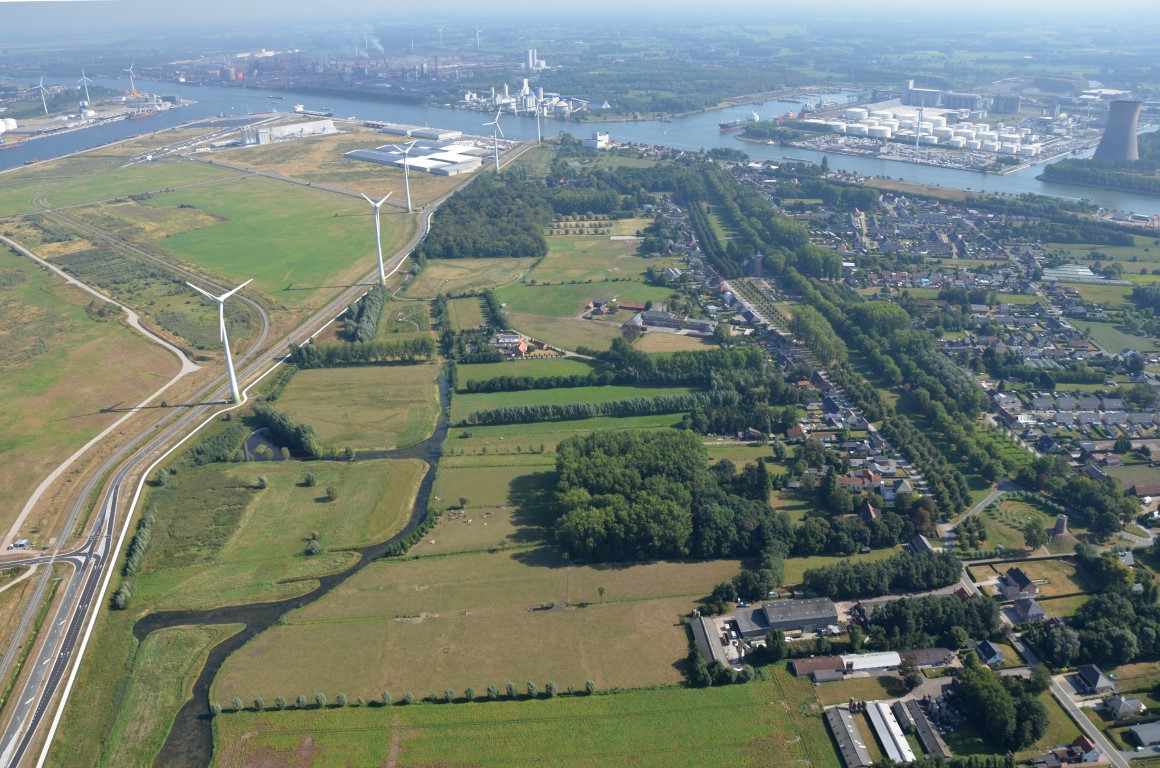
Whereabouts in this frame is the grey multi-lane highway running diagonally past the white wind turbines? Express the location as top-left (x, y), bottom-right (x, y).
top-left (0, 144), bottom-right (535, 768)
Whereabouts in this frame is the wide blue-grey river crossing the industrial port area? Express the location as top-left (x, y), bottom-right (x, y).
top-left (0, 78), bottom-right (1160, 216)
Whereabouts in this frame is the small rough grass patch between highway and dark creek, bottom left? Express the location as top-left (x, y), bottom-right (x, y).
top-left (100, 624), bottom-right (242, 768)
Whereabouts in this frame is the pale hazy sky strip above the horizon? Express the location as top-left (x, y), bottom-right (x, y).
top-left (0, 0), bottom-right (1157, 37)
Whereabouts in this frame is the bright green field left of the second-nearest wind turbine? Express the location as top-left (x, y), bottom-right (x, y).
top-left (138, 176), bottom-right (415, 305)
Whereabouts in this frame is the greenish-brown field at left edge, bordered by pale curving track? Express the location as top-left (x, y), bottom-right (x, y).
top-left (0, 248), bottom-right (177, 545)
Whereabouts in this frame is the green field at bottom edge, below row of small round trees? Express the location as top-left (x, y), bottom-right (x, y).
top-left (215, 669), bottom-right (841, 768)
